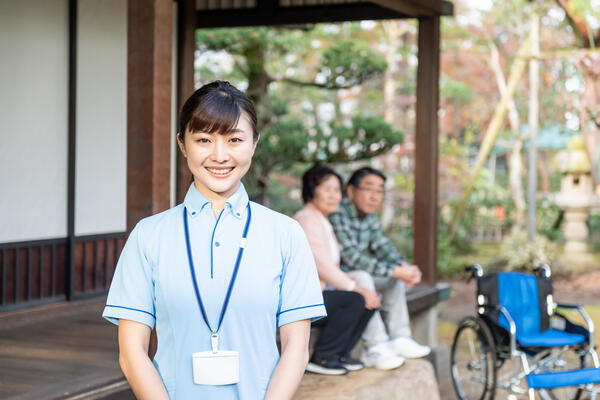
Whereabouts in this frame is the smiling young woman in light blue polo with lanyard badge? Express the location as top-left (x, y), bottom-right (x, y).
top-left (103, 81), bottom-right (326, 399)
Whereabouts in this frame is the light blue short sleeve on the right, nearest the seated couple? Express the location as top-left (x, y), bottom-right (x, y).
top-left (277, 221), bottom-right (327, 327)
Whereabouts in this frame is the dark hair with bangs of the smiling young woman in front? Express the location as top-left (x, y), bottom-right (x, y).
top-left (178, 81), bottom-right (258, 141)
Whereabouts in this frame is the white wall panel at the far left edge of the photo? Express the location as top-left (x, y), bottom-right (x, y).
top-left (0, 0), bottom-right (69, 243)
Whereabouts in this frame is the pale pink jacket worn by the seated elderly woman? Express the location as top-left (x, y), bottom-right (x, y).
top-left (294, 203), bottom-right (352, 290)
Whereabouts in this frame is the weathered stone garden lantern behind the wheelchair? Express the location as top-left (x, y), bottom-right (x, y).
top-left (556, 135), bottom-right (598, 260)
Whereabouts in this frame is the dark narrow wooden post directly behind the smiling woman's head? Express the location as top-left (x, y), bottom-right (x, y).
top-left (176, 0), bottom-right (196, 203)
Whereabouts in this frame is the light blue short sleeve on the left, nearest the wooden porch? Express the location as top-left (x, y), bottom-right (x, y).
top-left (102, 223), bottom-right (156, 328)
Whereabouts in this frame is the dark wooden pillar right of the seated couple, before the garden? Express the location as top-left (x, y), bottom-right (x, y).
top-left (413, 17), bottom-right (440, 284)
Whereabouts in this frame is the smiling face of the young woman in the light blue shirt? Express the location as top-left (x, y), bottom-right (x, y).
top-left (178, 113), bottom-right (257, 200)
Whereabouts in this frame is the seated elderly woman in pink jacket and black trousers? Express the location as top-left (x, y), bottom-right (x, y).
top-left (294, 165), bottom-right (404, 375)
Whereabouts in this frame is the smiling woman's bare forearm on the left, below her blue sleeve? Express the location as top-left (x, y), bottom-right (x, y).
top-left (119, 319), bottom-right (169, 400)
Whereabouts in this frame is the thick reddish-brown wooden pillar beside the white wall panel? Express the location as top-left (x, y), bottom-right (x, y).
top-left (127, 0), bottom-right (173, 232)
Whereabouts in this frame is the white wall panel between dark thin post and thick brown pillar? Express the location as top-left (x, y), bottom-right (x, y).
top-left (75, 0), bottom-right (127, 235)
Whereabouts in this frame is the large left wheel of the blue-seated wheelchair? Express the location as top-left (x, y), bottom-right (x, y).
top-left (450, 317), bottom-right (496, 400)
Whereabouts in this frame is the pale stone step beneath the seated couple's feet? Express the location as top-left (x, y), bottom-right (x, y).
top-left (294, 359), bottom-right (440, 400)
